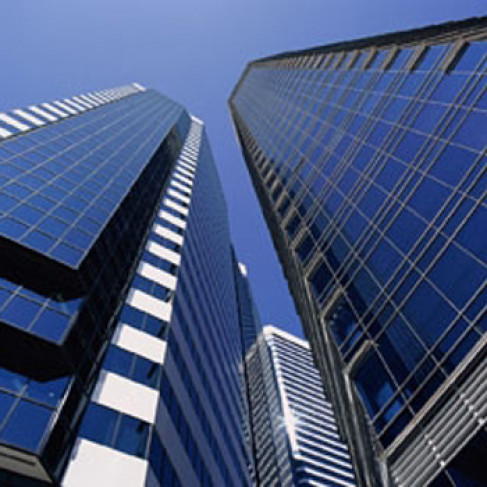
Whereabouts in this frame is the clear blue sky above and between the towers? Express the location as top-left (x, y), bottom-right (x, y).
top-left (0, 0), bottom-right (487, 335)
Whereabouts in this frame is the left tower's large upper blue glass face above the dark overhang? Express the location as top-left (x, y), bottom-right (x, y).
top-left (0, 91), bottom-right (182, 267)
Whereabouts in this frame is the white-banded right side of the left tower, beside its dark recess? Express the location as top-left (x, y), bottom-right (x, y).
top-left (65, 119), bottom-right (252, 487)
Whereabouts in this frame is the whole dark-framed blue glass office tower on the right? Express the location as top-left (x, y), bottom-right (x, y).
top-left (230, 18), bottom-right (487, 487)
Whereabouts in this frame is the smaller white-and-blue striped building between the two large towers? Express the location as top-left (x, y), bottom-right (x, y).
top-left (246, 325), bottom-right (355, 487)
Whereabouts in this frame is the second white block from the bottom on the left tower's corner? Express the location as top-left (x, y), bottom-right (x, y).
top-left (92, 370), bottom-right (159, 424)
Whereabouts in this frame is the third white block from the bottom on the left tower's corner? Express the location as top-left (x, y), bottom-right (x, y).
top-left (112, 324), bottom-right (166, 364)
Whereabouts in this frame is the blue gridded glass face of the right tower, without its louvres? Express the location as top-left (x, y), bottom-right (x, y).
top-left (231, 21), bottom-right (487, 487)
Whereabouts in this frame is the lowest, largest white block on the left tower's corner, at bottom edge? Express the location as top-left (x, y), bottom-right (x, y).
top-left (62, 438), bottom-right (149, 487)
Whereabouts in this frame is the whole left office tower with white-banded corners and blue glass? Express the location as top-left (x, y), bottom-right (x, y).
top-left (0, 84), bottom-right (248, 487)
